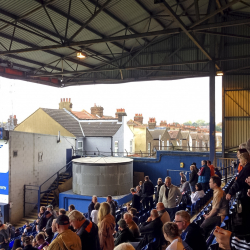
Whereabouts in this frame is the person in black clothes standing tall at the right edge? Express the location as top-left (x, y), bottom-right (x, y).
top-left (227, 149), bottom-right (250, 233)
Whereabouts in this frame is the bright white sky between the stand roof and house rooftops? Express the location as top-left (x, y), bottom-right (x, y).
top-left (0, 74), bottom-right (222, 124)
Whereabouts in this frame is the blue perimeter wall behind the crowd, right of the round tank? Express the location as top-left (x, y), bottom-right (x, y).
top-left (134, 151), bottom-right (221, 185)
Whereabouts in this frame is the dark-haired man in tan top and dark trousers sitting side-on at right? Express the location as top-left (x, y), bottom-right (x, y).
top-left (201, 176), bottom-right (229, 237)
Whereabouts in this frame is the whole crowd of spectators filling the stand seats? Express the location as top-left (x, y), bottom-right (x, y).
top-left (0, 142), bottom-right (250, 250)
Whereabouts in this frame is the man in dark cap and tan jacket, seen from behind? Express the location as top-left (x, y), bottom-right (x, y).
top-left (48, 215), bottom-right (82, 250)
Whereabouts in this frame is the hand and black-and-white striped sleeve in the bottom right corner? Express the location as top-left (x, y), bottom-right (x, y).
top-left (214, 227), bottom-right (250, 250)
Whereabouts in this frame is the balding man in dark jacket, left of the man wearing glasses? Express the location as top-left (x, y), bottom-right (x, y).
top-left (136, 209), bottom-right (162, 250)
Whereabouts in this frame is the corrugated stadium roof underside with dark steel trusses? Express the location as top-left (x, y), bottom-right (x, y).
top-left (0, 0), bottom-right (250, 87)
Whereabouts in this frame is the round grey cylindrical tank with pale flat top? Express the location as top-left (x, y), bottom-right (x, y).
top-left (73, 157), bottom-right (133, 196)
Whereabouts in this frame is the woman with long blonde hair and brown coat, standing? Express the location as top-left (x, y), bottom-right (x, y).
top-left (98, 202), bottom-right (115, 250)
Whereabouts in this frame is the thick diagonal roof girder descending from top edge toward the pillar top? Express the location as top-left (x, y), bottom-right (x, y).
top-left (163, 1), bottom-right (219, 69)
